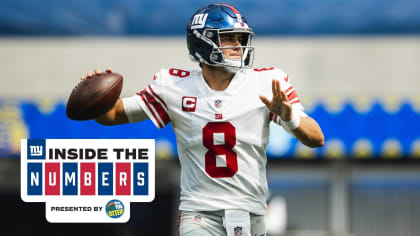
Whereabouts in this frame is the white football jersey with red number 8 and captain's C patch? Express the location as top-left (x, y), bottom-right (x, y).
top-left (125, 67), bottom-right (306, 215)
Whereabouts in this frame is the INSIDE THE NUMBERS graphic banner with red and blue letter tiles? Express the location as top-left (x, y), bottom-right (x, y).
top-left (21, 139), bottom-right (155, 223)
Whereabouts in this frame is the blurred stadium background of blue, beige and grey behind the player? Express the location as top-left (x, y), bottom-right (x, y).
top-left (0, 0), bottom-right (420, 236)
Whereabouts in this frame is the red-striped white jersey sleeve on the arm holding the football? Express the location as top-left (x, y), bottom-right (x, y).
top-left (137, 70), bottom-right (171, 129)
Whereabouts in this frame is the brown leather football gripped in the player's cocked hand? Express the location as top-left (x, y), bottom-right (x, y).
top-left (66, 72), bottom-right (123, 120)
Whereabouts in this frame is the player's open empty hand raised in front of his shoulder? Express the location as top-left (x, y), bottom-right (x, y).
top-left (260, 79), bottom-right (293, 121)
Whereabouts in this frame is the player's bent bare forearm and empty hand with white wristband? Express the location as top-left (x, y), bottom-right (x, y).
top-left (260, 80), bottom-right (324, 147)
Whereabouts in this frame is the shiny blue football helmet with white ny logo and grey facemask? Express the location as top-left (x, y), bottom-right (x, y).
top-left (187, 4), bottom-right (254, 72)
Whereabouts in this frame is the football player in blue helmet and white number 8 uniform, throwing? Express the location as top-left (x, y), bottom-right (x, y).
top-left (83, 4), bottom-right (324, 236)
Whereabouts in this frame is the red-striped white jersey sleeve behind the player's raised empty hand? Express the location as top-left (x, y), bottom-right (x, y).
top-left (270, 70), bottom-right (308, 133)
